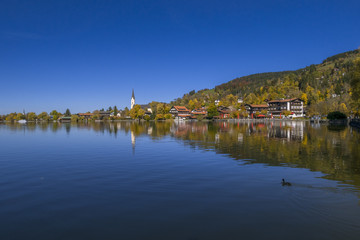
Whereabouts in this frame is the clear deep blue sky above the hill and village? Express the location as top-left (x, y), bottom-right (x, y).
top-left (0, 0), bottom-right (360, 114)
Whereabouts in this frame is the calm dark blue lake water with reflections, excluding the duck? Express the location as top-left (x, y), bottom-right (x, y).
top-left (0, 121), bottom-right (360, 240)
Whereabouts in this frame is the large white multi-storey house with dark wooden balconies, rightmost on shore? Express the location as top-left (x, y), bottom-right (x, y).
top-left (268, 98), bottom-right (304, 117)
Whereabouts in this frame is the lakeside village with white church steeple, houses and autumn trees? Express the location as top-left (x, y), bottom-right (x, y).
top-left (77, 91), bottom-right (305, 120)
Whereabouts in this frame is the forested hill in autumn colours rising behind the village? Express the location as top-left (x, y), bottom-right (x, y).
top-left (172, 49), bottom-right (360, 114)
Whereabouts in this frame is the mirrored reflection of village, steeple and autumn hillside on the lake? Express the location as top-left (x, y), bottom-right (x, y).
top-left (2, 121), bottom-right (360, 189)
